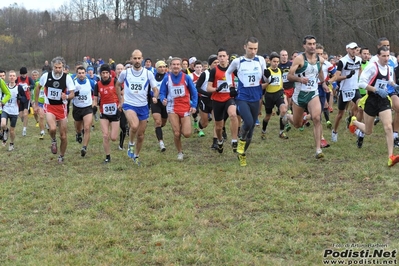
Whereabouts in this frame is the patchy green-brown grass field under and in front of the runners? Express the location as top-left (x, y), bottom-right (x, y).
top-left (0, 107), bottom-right (399, 265)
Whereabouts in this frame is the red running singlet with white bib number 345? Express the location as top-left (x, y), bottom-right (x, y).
top-left (97, 78), bottom-right (119, 115)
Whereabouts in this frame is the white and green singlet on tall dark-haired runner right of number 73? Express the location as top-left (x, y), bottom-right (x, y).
top-left (295, 54), bottom-right (320, 92)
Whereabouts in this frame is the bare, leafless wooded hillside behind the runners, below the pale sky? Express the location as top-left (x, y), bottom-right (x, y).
top-left (0, 0), bottom-right (399, 70)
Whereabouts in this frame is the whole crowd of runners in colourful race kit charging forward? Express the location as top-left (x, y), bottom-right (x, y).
top-left (0, 35), bottom-right (399, 166)
